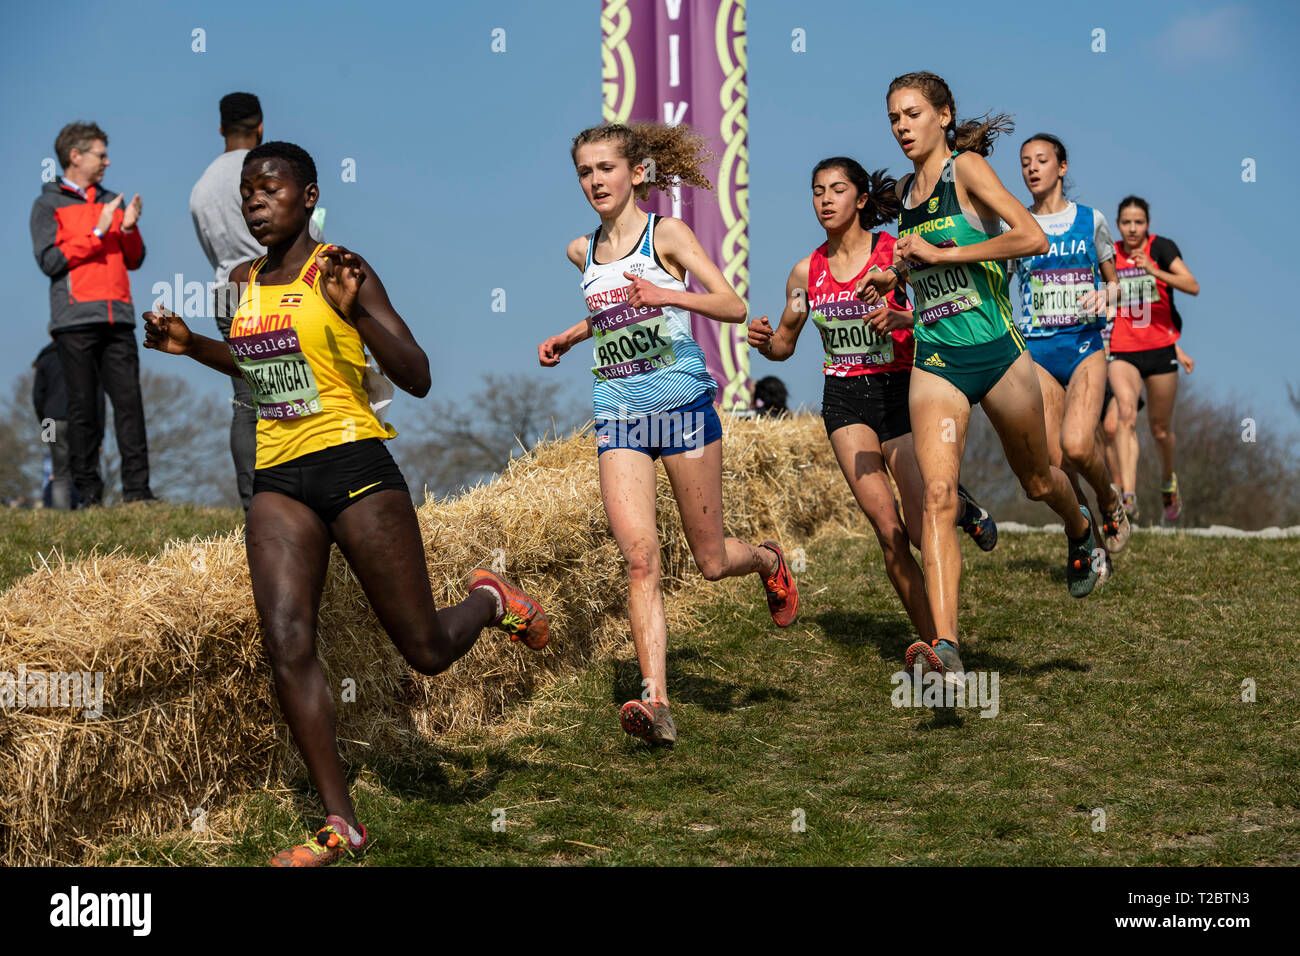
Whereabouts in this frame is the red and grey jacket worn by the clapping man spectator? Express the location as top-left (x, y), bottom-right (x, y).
top-left (31, 181), bottom-right (144, 332)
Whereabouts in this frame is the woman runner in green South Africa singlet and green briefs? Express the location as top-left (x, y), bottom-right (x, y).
top-left (858, 73), bottom-right (1100, 687)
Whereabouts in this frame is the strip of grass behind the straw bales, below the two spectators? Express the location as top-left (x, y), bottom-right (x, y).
top-left (0, 503), bottom-right (243, 589)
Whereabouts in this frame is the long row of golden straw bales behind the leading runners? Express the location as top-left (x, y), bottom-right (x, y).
top-left (0, 416), bottom-right (858, 865)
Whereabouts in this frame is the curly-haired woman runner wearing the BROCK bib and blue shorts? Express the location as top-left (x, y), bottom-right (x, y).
top-left (537, 124), bottom-right (800, 747)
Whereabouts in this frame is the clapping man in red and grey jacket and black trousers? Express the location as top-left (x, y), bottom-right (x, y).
top-left (31, 122), bottom-right (153, 505)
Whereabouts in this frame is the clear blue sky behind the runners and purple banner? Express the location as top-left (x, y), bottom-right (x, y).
top-left (0, 0), bottom-right (1300, 440)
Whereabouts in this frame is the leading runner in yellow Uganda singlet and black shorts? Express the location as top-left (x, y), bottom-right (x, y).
top-left (144, 143), bottom-right (549, 866)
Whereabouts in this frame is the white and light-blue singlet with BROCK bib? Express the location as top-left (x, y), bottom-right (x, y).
top-left (582, 212), bottom-right (718, 420)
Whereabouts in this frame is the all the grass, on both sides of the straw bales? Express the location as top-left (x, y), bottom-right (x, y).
top-left (12, 506), bottom-right (1279, 865)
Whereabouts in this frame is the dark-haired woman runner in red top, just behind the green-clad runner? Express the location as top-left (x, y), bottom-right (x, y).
top-left (749, 156), bottom-right (997, 645)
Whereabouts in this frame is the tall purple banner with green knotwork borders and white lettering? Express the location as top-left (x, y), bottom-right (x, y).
top-left (601, 0), bottom-right (753, 411)
